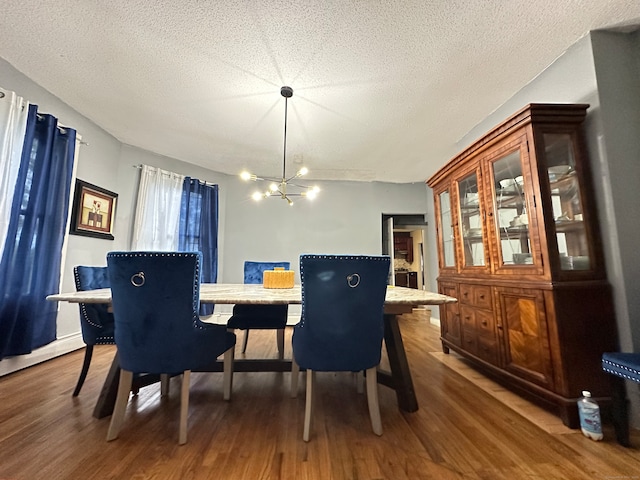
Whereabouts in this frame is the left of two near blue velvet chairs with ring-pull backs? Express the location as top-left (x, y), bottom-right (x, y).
top-left (107, 252), bottom-right (236, 445)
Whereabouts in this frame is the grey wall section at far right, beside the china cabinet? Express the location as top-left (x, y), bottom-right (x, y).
top-left (591, 32), bottom-right (640, 351)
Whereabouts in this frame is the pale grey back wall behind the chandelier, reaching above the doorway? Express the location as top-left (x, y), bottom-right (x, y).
top-left (222, 181), bottom-right (427, 283)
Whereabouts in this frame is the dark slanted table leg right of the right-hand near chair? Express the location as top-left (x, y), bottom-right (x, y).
top-left (378, 314), bottom-right (418, 412)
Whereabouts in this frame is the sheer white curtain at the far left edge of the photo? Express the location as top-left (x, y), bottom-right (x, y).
top-left (0, 88), bottom-right (29, 252)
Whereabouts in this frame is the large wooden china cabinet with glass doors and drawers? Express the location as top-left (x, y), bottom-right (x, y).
top-left (427, 104), bottom-right (616, 428)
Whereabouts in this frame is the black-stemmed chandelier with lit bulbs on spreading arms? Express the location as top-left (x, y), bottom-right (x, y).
top-left (240, 87), bottom-right (320, 205)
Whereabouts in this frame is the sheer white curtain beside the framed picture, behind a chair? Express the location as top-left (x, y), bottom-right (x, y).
top-left (131, 165), bottom-right (184, 251)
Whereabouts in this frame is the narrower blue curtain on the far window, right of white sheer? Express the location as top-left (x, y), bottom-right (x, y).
top-left (178, 177), bottom-right (218, 315)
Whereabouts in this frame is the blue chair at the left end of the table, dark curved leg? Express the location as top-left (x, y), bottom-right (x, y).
top-left (73, 265), bottom-right (115, 397)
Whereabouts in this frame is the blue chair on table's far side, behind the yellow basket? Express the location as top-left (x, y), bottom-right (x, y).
top-left (227, 261), bottom-right (290, 358)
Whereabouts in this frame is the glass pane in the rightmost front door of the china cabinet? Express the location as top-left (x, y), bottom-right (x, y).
top-left (491, 148), bottom-right (534, 266)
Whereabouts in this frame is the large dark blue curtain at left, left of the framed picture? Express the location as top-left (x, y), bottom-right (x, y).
top-left (0, 105), bottom-right (76, 359)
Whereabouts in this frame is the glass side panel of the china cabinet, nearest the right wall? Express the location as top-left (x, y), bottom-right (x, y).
top-left (543, 133), bottom-right (591, 270)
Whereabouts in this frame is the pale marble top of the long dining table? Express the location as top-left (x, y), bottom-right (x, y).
top-left (47, 283), bottom-right (457, 306)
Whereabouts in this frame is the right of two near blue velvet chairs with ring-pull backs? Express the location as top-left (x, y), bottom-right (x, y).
top-left (291, 255), bottom-right (390, 442)
